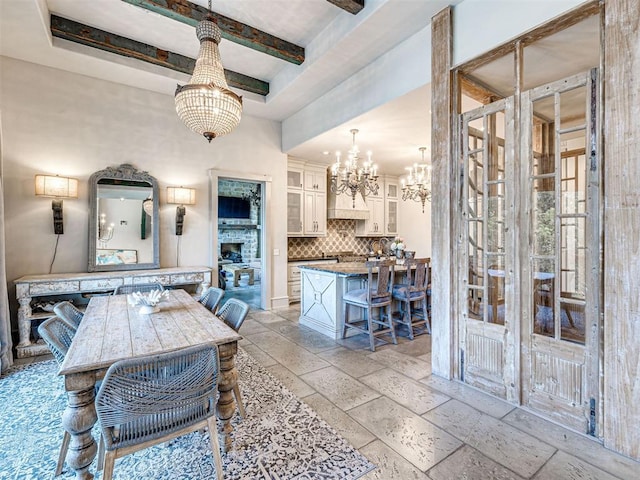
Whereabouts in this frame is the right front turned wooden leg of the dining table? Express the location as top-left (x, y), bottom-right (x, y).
top-left (216, 342), bottom-right (238, 453)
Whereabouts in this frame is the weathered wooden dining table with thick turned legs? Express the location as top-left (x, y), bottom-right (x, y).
top-left (59, 290), bottom-right (242, 479)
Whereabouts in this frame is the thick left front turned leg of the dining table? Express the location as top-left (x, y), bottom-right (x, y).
top-left (62, 380), bottom-right (98, 480)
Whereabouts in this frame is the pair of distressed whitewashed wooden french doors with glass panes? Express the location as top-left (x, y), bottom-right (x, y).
top-left (458, 70), bottom-right (601, 435)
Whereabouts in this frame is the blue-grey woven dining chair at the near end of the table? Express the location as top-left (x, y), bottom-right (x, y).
top-left (96, 345), bottom-right (223, 480)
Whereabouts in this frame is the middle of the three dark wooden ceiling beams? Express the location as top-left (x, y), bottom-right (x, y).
top-left (122, 0), bottom-right (308, 65)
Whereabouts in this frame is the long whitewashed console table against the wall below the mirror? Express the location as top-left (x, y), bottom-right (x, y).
top-left (14, 267), bottom-right (211, 358)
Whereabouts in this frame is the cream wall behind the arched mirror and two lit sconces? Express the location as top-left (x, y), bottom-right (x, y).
top-left (0, 57), bottom-right (287, 318)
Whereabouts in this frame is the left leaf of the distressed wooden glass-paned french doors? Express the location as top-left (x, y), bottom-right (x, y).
top-left (460, 99), bottom-right (514, 398)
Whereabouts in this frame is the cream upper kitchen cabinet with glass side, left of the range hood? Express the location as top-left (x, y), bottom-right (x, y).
top-left (287, 160), bottom-right (327, 237)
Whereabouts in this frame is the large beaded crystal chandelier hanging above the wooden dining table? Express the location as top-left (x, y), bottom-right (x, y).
top-left (175, 0), bottom-right (242, 142)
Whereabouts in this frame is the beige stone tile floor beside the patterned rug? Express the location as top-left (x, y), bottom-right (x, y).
top-left (17, 304), bottom-right (640, 480)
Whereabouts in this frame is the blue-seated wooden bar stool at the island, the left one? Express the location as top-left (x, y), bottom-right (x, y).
top-left (342, 259), bottom-right (398, 352)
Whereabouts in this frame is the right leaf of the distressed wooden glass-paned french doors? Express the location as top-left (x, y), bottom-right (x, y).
top-left (521, 71), bottom-right (600, 434)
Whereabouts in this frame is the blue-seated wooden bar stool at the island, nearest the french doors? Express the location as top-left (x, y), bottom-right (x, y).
top-left (392, 258), bottom-right (431, 340)
